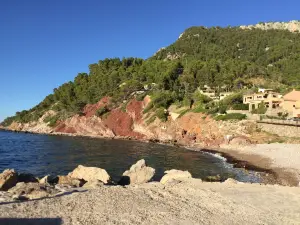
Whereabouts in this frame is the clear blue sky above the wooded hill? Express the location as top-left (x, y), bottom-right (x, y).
top-left (0, 0), bottom-right (300, 121)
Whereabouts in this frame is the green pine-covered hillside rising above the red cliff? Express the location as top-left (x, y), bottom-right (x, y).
top-left (2, 22), bottom-right (300, 126)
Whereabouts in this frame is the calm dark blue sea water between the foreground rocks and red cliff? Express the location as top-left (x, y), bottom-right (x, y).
top-left (0, 131), bottom-right (260, 182)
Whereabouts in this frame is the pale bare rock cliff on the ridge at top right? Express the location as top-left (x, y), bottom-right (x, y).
top-left (240, 20), bottom-right (300, 32)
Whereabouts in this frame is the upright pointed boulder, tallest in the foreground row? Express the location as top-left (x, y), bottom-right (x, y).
top-left (119, 159), bottom-right (155, 185)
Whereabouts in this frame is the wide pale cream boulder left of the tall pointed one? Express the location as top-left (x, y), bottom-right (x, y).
top-left (68, 165), bottom-right (110, 184)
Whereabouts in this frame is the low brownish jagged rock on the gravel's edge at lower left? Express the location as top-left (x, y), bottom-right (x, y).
top-left (8, 182), bottom-right (58, 199)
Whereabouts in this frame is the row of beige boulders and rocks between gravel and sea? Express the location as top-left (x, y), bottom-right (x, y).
top-left (0, 159), bottom-right (192, 202)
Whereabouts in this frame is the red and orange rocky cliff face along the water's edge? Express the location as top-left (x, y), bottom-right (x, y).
top-left (5, 97), bottom-right (268, 146)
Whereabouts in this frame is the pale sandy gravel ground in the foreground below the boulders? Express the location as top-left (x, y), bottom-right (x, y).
top-left (0, 179), bottom-right (300, 225)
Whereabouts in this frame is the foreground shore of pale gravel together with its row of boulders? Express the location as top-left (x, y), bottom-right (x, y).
top-left (0, 160), bottom-right (300, 225)
